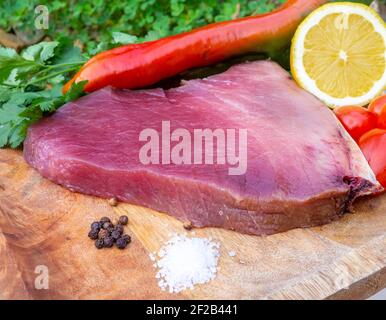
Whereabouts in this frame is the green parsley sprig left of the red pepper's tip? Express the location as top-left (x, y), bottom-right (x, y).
top-left (0, 38), bottom-right (86, 148)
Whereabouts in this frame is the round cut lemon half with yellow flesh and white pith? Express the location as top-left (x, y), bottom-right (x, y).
top-left (291, 2), bottom-right (386, 107)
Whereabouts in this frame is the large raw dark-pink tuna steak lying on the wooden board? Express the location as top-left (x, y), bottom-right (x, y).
top-left (24, 61), bottom-right (381, 235)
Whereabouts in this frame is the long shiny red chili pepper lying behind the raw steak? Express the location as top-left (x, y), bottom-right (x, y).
top-left (63, 0), bottom-right (328, 93)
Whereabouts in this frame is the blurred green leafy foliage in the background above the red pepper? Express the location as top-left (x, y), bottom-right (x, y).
top-left (0, 0), bottom-right (285, 52)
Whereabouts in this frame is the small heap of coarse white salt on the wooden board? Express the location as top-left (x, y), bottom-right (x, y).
top-left (150, 234), bottom-right (220, 293)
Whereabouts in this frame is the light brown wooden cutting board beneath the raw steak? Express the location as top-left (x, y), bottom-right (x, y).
top-left (0, 150), bottom-right (386, 299)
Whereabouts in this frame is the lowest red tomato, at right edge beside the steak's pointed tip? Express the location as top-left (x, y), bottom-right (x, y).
top-left (359, 129), bottom-right (386, 188)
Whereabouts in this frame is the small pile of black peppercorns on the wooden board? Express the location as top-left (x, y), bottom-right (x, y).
top-left (88, 216), bottom-right (131, 249)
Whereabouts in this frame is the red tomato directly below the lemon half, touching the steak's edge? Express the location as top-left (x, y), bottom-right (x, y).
top-left (335, 106), bottom-right (378, 141)
